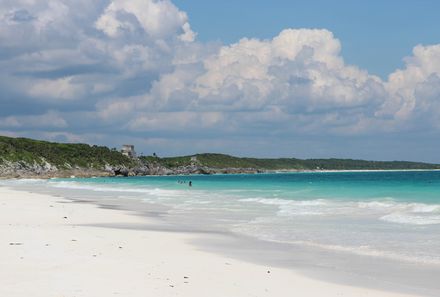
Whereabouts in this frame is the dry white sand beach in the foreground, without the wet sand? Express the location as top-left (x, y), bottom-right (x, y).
top-left (0, 187), bottom-right (424, 297)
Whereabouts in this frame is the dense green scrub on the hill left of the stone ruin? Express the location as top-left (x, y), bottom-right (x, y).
top-left (0, 136), bottom-right (133, 169)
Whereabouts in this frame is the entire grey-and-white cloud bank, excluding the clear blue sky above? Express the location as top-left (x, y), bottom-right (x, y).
top-left (0, 0), bottom-right (440, 162)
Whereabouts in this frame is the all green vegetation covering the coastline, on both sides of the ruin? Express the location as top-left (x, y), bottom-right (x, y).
top-left (0, 136), bottom-right (440, 170)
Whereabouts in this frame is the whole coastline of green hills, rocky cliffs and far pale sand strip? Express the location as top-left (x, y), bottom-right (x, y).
top-left (0, 136), bottom-right (440, 178)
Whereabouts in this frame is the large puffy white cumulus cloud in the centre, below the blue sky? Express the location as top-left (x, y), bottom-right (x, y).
top-left (111, 29), bottom-right (386, 132)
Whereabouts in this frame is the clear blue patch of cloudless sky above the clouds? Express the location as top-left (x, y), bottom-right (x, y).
top-left (174, 0), bottom-right (440, 79)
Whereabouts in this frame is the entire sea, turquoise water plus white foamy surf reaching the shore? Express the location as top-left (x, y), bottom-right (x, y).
top-left (5, 171), bottom-right (440, 265)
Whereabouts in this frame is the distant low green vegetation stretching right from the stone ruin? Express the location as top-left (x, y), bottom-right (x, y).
top-left (141, 154), bottom-right (440, 170)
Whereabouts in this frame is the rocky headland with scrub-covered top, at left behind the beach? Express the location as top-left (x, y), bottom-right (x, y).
top-left (0, 136), bottom-right (259, 178)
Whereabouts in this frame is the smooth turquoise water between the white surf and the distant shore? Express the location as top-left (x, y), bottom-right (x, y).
top-left (58, 171), bottom-right (440, 203)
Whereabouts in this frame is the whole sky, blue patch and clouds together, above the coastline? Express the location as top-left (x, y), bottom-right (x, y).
top-left (0, 0), bottom-right (440, 163)
